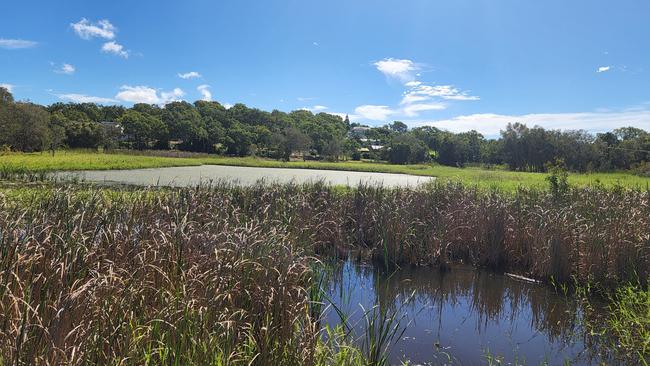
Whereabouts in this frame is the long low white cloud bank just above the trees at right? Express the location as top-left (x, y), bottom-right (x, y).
top-left (409, 108), bottom-right (650, 136)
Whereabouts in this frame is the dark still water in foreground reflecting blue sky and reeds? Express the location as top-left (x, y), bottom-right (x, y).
top-left (325, 262), bottom-right (616, 365)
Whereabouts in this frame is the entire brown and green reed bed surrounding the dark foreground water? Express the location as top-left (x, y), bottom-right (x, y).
top-left (0, 183), bottom-right (650, 365)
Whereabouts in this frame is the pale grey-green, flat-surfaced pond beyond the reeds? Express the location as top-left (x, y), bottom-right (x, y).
top-left (55, 165), bottom-right (434, 187)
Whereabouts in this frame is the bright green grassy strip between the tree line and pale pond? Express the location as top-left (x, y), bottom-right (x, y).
top-left (0, 151), bottom-right (650, 189)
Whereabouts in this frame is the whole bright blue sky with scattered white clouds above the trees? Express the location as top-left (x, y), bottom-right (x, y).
top-left (0, 0), bottom-right (650, 136)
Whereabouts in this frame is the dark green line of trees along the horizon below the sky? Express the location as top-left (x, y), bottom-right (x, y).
top-left (0, 88), bottom-right (650, 172)
